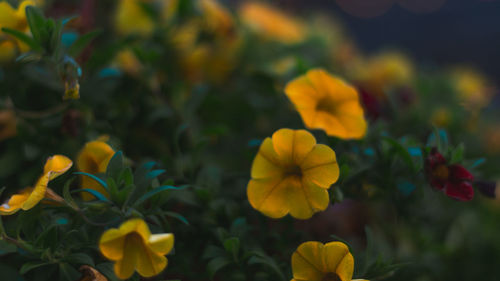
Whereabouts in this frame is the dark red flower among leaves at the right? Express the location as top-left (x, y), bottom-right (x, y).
top-left (425, 148), bottom-right (474, 201)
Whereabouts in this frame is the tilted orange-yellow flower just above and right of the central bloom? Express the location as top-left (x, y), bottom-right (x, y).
top-left (285, 69), bottom-right (367, 139)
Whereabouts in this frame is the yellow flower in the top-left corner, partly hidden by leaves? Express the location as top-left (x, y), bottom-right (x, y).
top-left (0, 1), bottom-right (36, 63)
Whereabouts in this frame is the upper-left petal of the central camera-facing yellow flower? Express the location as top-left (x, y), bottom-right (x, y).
top-left (251, 138), bottom-right (283, 179)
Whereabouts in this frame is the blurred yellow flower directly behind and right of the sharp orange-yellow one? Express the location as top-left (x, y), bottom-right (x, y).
top-left (356, 51), bottom-right (415, 97)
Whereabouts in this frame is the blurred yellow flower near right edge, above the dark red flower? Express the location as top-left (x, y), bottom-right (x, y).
top-left (451, 68), bottom-right (493, 110)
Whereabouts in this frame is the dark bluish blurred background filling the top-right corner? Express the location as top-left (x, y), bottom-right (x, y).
top-left (277, 0), bottom-right (500, 84)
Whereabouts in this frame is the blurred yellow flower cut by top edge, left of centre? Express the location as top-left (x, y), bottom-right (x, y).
top-left (114, 0), bottom-right (155, 37)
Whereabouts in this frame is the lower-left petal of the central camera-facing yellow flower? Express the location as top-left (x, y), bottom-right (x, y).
top-left (247, 178), bottom-right (289, 218)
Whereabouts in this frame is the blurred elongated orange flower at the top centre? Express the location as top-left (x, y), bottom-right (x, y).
top-left (239, 2), bottom-right (306, 44)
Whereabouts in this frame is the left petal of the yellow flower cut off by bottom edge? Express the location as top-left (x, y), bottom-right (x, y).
top-left (292, 241), bottom-right (325, 281)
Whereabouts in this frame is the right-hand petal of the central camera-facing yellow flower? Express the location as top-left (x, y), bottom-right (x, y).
top-left (301, 144), bottom-right (339, 188)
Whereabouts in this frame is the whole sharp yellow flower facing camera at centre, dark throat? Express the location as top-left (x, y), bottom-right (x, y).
top-left (247, 129), bottom-right (339, 219)
